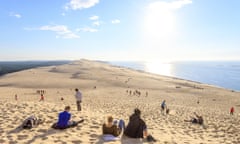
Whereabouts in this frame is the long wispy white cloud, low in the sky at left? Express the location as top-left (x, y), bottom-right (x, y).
top-left (39, 25), bottom-right (79, 39)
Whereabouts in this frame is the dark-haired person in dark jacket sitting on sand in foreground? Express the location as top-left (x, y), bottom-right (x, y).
top-left (124, 108), bottom-right (156, 142)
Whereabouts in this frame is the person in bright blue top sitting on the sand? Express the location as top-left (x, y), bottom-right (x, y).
top-left (52, 106), bottom-right (84, 129)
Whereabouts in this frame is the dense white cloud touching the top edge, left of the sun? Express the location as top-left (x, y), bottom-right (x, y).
top-left (65, 0), bottom-right (99, 10)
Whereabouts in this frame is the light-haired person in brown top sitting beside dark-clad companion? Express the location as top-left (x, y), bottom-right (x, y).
top-left (102, 116), bottom-right (125, 137)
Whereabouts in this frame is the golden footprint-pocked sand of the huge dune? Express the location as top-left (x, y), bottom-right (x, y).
top-left (0, 60), bottom-right (240, 144)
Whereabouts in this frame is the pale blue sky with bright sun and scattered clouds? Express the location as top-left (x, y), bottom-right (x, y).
top-left (0, 0), bottom-right (240, 61)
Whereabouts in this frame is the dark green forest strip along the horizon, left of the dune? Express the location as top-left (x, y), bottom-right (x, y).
top-left (0, 60), bottom-right (71, 76)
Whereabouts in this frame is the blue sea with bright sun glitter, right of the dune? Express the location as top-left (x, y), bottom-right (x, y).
top-left (109, 61), bottom-right (240, 91)
